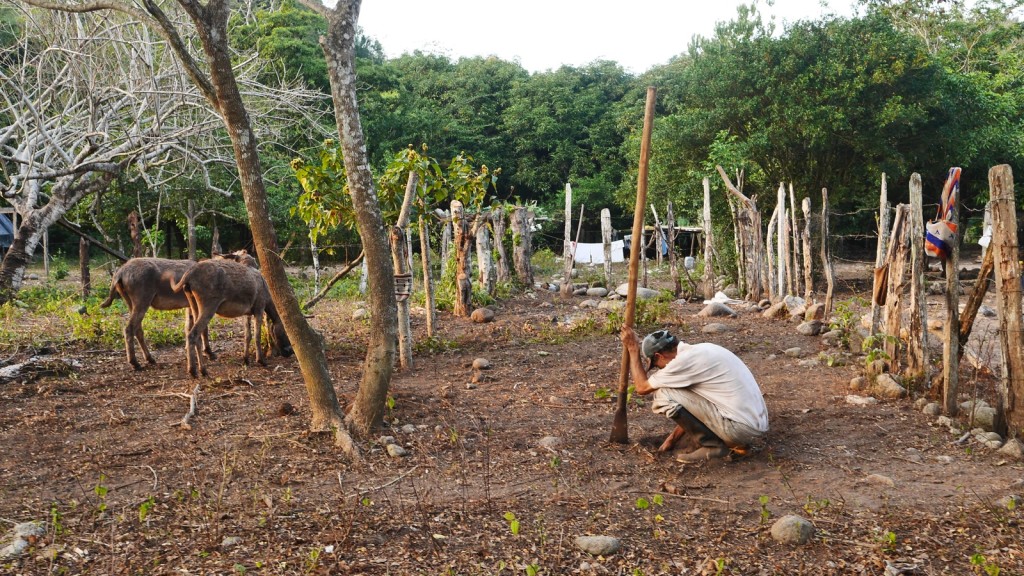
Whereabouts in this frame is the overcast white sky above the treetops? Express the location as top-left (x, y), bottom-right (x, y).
top-left (359, 0), bottom-right (854, 74)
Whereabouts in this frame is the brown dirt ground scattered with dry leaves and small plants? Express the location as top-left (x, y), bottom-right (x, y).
top-left (0, 258), bottom-right (1024, 575)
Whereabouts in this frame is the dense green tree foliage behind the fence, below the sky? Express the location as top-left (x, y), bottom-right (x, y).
top-left (0, 0), bottom-right (1024, 258)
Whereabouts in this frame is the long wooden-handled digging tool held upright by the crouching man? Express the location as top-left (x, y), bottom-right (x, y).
top-left (610, 86), bottom-right (657, 444)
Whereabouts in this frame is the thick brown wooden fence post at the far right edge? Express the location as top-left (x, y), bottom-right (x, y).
top-left (988, 164), bottom-right (1024, 438)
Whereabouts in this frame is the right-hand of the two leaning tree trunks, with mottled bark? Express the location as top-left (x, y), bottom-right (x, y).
top-left (321, 0), bottom-right (397, 437)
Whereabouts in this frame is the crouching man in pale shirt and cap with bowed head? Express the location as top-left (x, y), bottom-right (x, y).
top-left (622, 326), bottom-right (768, 462)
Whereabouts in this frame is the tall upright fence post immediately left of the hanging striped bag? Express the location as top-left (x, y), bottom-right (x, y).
top-left (905, 173), bottom-right (928, 383)
